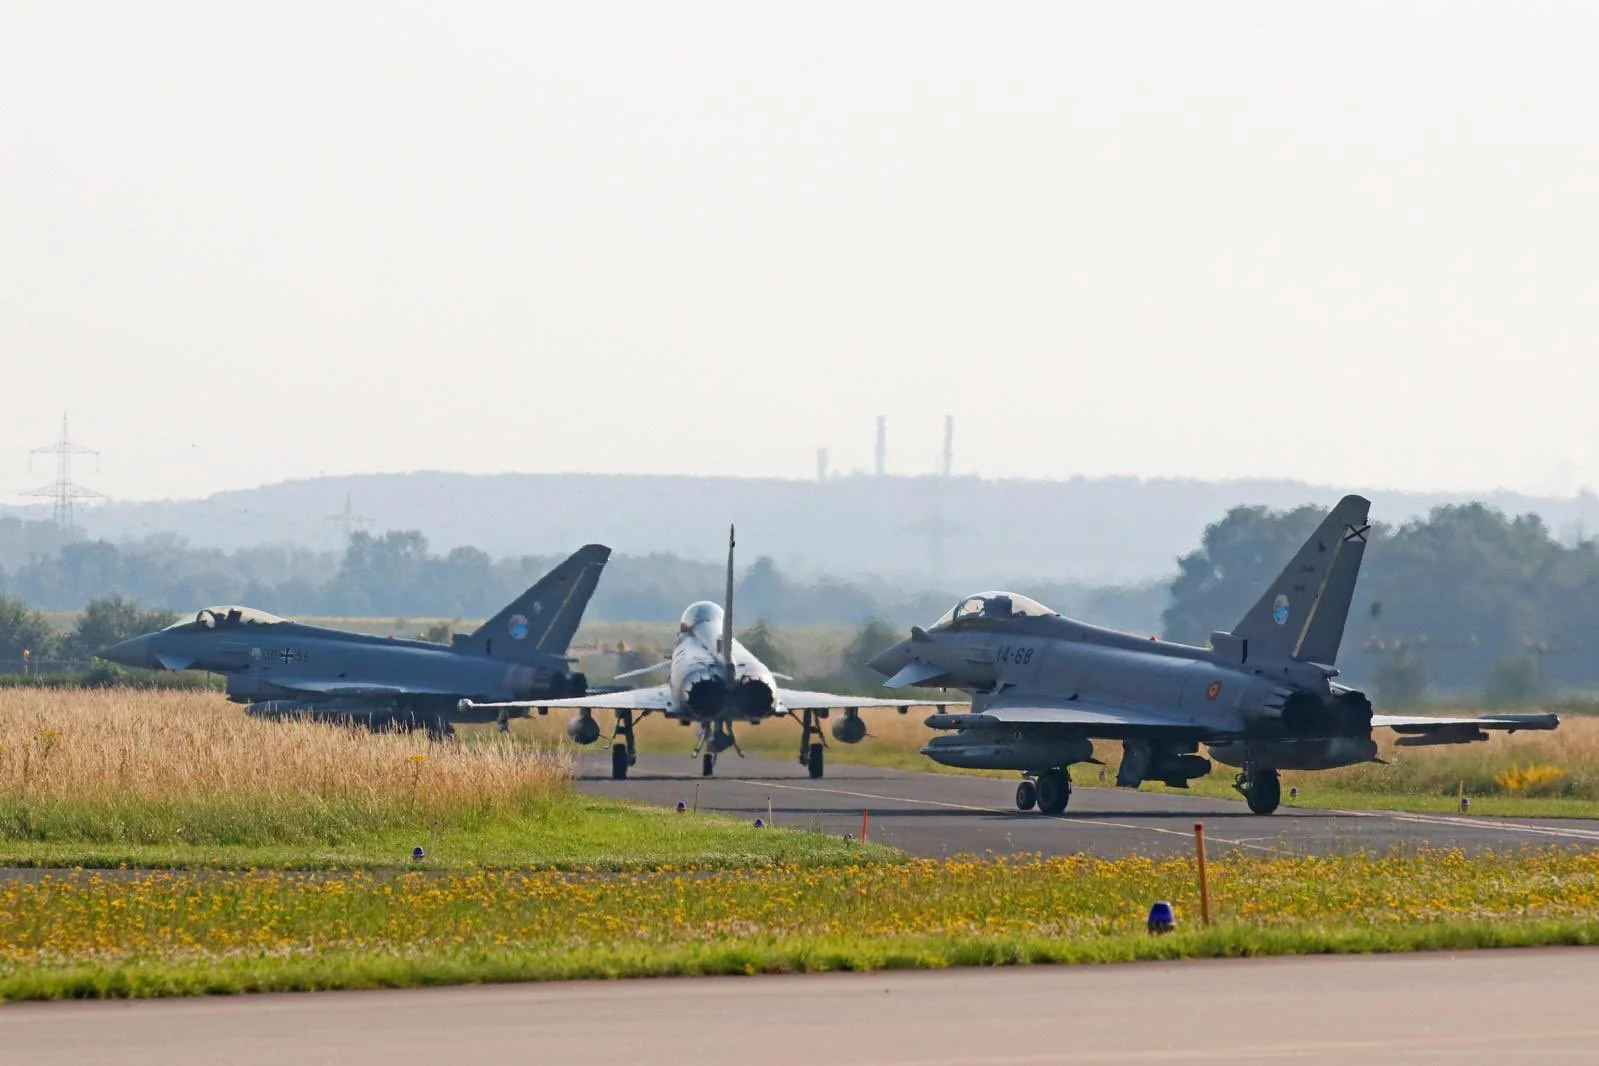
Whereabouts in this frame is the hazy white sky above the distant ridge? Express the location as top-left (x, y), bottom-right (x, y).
top-left (0, 0), bottom-right (1599, 500)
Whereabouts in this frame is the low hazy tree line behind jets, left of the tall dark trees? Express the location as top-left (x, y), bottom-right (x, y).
top-left (0, 518), bottom-right (1164, 631)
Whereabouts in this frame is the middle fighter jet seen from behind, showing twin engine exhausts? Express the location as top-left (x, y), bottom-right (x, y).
top-left (462, 527), bottom-right (964, 780)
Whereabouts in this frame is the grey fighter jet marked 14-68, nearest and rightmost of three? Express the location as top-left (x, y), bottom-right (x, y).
top-left (870, 495), bottom-right (1559, 815)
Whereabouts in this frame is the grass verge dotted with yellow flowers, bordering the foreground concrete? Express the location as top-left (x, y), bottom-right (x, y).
top-left (0, 849), bottom-right (1599, 999)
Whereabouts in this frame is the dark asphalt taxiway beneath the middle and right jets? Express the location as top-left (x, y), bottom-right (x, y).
top-left (579, 751), bottom-right (1599, 858)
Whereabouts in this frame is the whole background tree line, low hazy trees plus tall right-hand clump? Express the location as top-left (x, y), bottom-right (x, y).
top-left (0, 503), bottom-right (1599, 703)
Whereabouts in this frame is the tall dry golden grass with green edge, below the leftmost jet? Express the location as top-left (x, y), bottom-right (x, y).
top-left (0, 689), bottom-right (889, 869)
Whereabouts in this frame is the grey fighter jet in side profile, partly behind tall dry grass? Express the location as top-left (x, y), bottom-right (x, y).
top-left (101, 543), bottom-right (611, 735)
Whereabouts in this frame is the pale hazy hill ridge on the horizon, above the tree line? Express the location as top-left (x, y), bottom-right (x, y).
top-left (13, 471), bottom-right (1599, 587)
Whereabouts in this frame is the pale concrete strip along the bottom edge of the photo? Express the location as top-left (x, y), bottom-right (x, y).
top-left (12, 948), bottom-right (1599, 1066)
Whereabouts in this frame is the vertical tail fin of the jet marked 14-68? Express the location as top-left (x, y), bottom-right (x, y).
top-left (1233, 495), bottom-right (1372, 666)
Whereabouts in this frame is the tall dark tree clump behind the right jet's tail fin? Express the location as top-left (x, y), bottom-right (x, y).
top-left (1162, 503), bottom-right (1599, 705)
